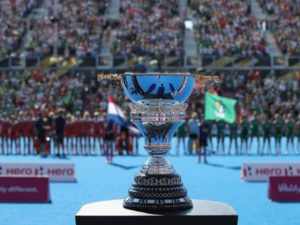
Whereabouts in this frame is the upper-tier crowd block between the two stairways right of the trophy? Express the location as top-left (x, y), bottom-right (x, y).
top-left (189, 0), bottom-right (266, 56)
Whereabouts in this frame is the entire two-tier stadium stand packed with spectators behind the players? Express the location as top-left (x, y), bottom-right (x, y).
top-left (0, 0), bottom-right (300, 156)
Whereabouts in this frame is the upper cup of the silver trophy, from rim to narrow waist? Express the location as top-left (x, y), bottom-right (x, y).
top-left (122, 73), bottom-right (195, 153)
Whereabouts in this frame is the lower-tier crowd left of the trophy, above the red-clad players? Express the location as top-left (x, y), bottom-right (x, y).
top-left (0, 71), bottom-right (124, 116)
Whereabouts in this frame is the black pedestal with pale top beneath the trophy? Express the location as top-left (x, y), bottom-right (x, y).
top-left (76, 200), bottom-right (238, 225)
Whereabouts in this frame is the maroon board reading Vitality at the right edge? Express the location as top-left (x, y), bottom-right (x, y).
top-left (269, 176), bottom-right (300, 202)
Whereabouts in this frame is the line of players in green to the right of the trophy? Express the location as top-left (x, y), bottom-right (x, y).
top-left (187, 114), bottom-right (300, 155)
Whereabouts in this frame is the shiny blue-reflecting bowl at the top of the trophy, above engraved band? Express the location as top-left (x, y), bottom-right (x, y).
top-left (122, 73), bottom-right (195, 102)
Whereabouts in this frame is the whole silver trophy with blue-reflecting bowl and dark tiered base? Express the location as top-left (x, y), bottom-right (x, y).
top-left (121, 73), bottom-right (195, 211)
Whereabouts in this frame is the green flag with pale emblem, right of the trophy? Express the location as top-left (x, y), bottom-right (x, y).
top-left (204, 92), bottom-right (237, 123)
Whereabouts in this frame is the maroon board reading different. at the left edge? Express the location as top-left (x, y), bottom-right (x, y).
top-left (0, 176), bottom-right (50, 202)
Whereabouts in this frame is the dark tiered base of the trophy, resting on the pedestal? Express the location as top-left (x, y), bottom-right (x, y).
top-left (123, 173), bottom-right (193, 212)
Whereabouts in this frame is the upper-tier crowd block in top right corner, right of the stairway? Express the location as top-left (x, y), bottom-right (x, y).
top-left (259, 0), bottom-right (300, 56)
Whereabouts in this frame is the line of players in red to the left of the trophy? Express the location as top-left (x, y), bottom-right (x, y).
top-left (0, 112), bottom-right (138, 156)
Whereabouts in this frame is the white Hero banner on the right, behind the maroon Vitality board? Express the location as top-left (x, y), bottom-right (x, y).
top-left (241, 163), bottom-right (300, 182)
